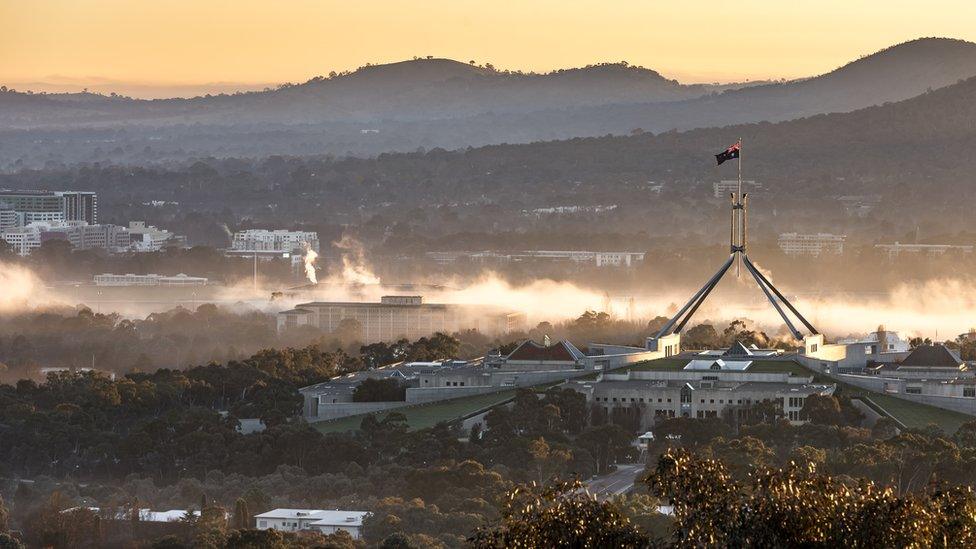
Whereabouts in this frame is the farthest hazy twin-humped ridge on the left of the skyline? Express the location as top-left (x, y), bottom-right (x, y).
top-left (0, 59), bottom-right (716, 126)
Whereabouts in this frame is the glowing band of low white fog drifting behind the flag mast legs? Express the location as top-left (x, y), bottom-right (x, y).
top-left (0, 253), bottom-right (976, 340)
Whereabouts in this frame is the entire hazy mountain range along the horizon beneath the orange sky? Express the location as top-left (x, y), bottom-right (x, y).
top-left (0, 38), bottom-right (976, 169)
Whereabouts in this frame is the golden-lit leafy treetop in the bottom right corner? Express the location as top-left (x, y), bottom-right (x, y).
top-left (645, 450), bottom-right (976, 547)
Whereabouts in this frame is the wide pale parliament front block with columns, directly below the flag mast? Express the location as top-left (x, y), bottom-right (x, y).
top-left (569, 358), bottom-right (836, 430)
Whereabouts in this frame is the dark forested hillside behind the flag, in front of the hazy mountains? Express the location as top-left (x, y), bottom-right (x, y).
top-left (0, 71), bottom-right (976, 230)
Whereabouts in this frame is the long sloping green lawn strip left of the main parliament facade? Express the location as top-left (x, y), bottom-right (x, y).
top-left (312, 389), bottom-right (515, 433)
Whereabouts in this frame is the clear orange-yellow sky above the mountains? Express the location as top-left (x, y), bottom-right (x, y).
top-left (0, 0), bottom-right (976, 97)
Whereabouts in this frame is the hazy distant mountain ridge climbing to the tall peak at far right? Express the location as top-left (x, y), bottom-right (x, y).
top-left (450, 38), bottom-right (976, 141)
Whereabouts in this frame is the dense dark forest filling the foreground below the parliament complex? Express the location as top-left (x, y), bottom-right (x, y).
top-left (0, 349), bottom-right (976, 547)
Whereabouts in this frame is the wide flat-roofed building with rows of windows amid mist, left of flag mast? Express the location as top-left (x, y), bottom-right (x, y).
top-left (278, 296), bottom-right (525, 344)
